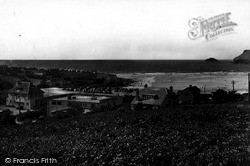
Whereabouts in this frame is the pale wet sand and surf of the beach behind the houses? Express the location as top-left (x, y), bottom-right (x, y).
top-left (117, 72), bottom-right (248, 94)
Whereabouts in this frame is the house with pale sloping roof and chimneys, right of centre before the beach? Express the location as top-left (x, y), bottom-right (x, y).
top-left (131, 87), bottom-right (167, 110)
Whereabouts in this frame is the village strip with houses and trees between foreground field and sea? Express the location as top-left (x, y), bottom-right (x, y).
top-left (0, 66), bottom-right (247, 124)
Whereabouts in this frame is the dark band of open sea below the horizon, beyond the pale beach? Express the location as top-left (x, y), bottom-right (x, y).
top-left (0, 60), bottom-right (250, 74)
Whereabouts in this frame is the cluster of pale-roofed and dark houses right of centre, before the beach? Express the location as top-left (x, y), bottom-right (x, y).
top-left (131, 85), bottom-right (212, 110)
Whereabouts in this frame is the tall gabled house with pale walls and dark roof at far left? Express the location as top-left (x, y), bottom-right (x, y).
top-left (6, 81), bottom-right (44, 110)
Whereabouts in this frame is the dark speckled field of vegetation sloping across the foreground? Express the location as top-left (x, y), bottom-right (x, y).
top-left (0, 104), bottom-right (250, 166)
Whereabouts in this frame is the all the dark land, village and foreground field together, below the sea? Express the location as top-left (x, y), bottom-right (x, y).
top-left (0, 66), bottom-right (249, 165)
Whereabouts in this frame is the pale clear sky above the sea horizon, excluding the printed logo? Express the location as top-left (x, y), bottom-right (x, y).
top-left (0, 0), bottom-right (250, 60)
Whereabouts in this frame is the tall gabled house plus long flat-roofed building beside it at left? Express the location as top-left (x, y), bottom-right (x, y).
top-left (6, 81), bottom-right (122, 116)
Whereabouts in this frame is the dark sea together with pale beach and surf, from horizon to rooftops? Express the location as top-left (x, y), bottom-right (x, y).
top-left (0, 60), bottom-right (250, 93)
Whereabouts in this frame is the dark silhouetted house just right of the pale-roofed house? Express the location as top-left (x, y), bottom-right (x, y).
top-left (177, 85), bottom-right (200, 105)
